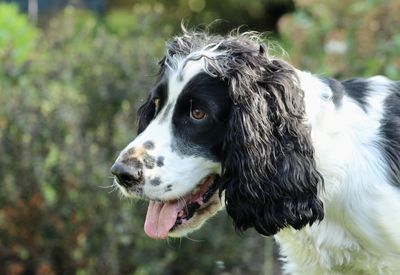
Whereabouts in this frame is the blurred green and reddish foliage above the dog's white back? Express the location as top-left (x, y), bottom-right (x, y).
top-left (279, 0), bottom-right (400, 79)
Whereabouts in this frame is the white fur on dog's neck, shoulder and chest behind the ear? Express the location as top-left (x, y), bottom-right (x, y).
top-left (275, 71), bottom-right (400, 274)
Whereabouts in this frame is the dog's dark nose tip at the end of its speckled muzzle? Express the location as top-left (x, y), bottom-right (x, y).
top-left (111, 162), bottom-right (143, 187)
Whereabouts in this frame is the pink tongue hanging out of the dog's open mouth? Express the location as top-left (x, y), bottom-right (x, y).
top-left (144, 200), bottom-right (184, 239)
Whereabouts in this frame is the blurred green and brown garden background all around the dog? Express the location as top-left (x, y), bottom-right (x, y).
top-left (0, 0), bottom-right (400, 275)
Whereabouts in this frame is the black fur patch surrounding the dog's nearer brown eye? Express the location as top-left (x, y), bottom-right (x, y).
top-left (172, 73), bottom-right (231, 160)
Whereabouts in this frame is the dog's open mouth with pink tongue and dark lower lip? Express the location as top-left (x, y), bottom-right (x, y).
top-left (144, 174), bottom-right (218, 239)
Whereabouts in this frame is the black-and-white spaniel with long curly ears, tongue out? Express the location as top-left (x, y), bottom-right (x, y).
top-left (111, 30), bottom-right (400, 274)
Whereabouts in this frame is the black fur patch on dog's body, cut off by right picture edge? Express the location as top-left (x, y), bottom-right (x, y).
top-left (380, 82), bottom-right (400, 186)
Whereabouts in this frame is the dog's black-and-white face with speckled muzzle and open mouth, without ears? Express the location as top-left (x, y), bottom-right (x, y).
top-left (113, 61), bottom-right (231, 238)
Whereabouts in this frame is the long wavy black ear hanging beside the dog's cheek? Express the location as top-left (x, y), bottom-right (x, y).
top-left (220, 54), bottom-right (324, 235)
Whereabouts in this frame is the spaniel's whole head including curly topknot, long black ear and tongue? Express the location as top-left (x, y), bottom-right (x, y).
top-left (112, 32), bottom-right (323, 238)
